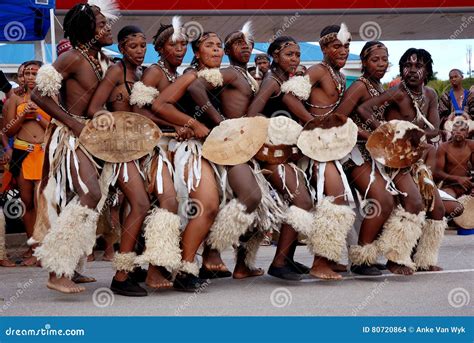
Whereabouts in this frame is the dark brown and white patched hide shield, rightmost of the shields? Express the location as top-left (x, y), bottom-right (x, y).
top-left (365, 120), bottom-right (426, 168)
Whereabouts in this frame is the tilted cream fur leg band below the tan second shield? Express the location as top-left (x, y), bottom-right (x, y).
top-left (208, 199), bottom-right (255, 251)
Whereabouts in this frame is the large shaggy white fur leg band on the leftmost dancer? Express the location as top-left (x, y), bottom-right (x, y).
top-left (34, 200), bottom-right (99, 278)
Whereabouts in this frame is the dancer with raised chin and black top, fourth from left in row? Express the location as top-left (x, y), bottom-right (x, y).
top-left (151, 32), bottom-right (224, 291)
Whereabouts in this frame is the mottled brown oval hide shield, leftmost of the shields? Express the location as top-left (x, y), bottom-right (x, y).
top-left (79, 111), bottom-right (161, 163)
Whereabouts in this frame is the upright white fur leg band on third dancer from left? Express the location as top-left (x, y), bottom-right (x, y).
top-left (137, 208), bottom-right (181, 272)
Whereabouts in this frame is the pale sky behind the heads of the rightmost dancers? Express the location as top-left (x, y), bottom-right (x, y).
top-left (350, 39), bottom-right (474, 82)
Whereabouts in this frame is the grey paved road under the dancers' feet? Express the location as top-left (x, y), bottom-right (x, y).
top-left (0, 232), bottom-right (474, 316)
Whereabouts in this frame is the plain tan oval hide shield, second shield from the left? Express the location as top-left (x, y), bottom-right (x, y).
top-left (202, 117), bottom-right (268, 166)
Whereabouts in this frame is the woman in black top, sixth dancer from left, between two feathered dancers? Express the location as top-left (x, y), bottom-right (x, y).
top-left (248, 36), bottom-right (313, 281)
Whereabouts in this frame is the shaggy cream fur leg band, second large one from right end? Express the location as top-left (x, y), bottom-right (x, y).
top-left (377, 206), bottom-right (425, 269)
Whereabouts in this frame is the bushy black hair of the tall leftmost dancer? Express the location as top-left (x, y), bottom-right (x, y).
top-left (63, 4), bottom-right (96, 47)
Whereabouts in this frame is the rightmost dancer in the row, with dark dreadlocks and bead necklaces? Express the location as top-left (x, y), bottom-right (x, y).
top-left (357, 48), bottom-right (447, 274)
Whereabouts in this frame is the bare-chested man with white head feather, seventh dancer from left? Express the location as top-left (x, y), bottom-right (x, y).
top-left (282, 25), bottom-right (355, 280)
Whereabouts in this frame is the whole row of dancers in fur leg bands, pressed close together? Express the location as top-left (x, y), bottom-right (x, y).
top-left (0, 0), bottom-right (470, 296)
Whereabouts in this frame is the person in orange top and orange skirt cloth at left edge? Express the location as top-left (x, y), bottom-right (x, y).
top-left (4, 61), bottom-right (51, 266)
